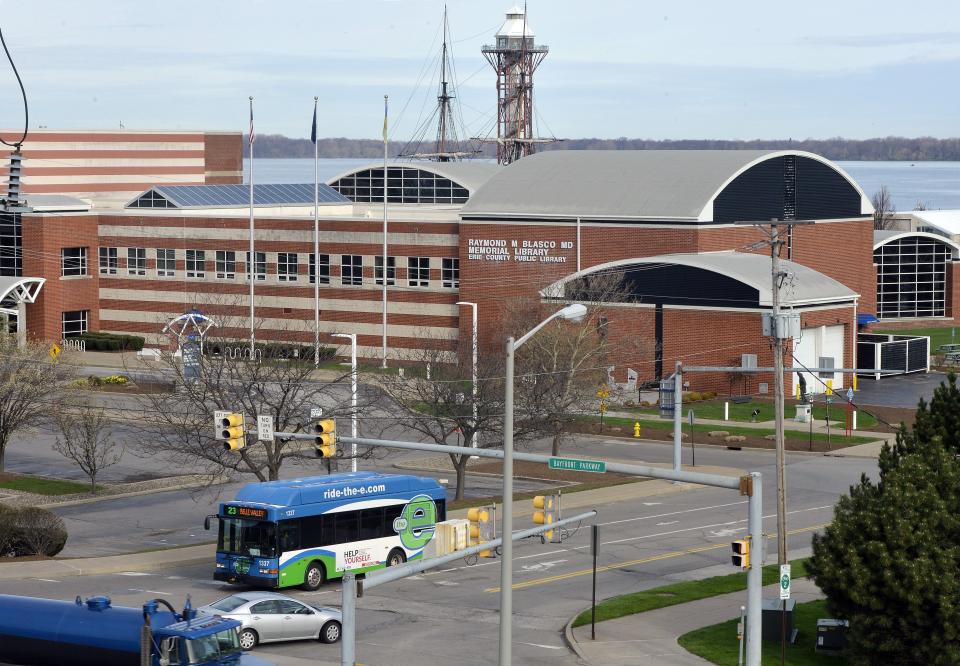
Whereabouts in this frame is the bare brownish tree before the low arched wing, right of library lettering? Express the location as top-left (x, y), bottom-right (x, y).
top-left (509, 272), bottom-right (650, 456)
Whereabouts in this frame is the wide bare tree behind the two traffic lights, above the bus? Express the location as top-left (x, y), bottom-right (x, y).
top-left (134, 322), bottom-right (373, 482)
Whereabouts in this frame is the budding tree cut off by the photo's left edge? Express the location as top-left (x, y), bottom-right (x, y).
top-left (0, 334), bottom-right (74, 472)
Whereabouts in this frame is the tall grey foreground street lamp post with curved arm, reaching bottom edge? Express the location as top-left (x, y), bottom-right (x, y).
top-left (500, 303), bottom-right (587, 666)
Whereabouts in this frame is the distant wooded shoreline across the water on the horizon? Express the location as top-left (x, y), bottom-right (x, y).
top-left (244, 134), bottom-right (960, 162)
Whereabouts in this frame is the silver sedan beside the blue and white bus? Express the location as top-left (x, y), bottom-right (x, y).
top-left (197, 592), bottom-right (341, 650)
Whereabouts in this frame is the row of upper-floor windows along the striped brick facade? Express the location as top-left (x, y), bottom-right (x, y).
top-left (94, 247), bottom-right (460, 289)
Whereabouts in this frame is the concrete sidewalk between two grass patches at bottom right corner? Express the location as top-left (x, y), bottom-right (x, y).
top-left (566, 578), bottom-right (823, 666)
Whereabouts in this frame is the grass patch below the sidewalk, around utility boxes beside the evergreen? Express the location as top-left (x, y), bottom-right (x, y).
top-left (677, 600), bottom-right (847, 666)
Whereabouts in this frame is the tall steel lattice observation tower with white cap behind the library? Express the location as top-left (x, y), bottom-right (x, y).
top-left (483, 7), bottom-right (549, 164)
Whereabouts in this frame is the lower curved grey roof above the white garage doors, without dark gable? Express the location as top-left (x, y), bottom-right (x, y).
top-left (540, 250), bottom-right (859, 307)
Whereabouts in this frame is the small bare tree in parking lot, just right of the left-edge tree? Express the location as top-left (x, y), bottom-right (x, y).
top-left (53, 399), bottom-right (123, 493)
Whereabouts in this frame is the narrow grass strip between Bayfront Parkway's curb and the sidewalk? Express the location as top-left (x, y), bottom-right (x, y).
top-left (573, 558), bottom-right (808, 624)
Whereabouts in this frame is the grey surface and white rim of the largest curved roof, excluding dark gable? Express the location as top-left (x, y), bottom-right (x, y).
top-left (462, 150), bottom-right (873, 222)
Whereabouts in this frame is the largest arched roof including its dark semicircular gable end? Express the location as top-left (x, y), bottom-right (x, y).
top-left (461, 150), bottom-right (873, 223)
